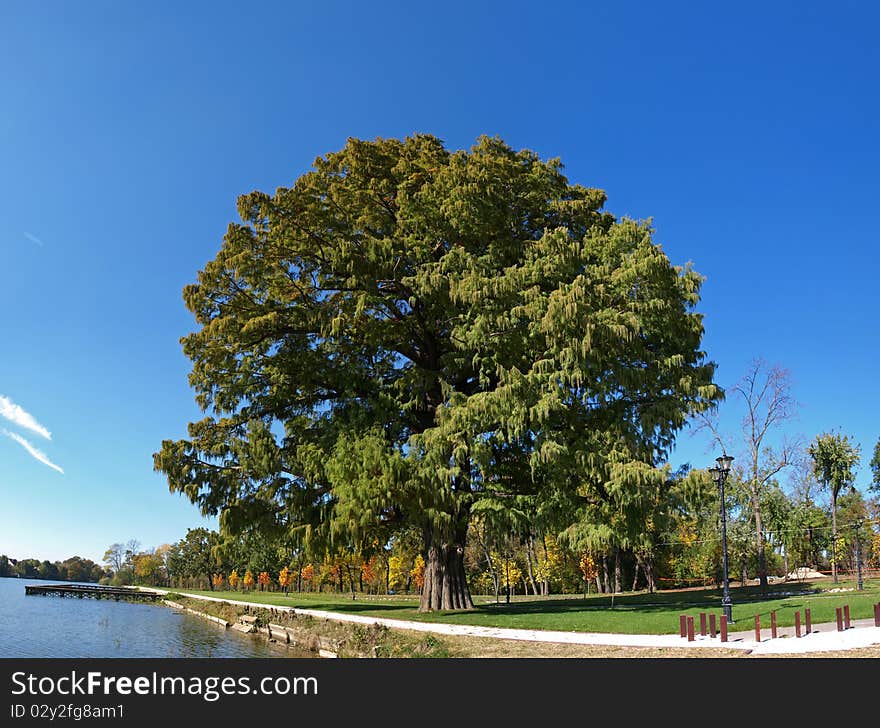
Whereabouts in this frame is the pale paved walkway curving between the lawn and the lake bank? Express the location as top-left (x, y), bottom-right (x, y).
top-left (152, 589), bottom-right (880, 655)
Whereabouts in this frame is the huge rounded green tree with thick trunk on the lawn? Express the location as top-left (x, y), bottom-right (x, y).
top-left (154, 135), bottom-right (719, 610)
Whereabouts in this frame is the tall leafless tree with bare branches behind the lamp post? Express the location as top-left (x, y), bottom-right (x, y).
top-left (697, 359), bottom-right (803, 588)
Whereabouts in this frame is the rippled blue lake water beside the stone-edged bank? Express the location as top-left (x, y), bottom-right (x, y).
top-left (0, 578), bottom-right (307, 657)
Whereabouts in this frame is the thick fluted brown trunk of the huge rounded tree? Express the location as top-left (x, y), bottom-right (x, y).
top-left (419, 522), bottom-right (474, 612)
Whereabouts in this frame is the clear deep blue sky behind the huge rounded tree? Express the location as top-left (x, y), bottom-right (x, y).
top-left (0, 0), bottom-right (880, 560)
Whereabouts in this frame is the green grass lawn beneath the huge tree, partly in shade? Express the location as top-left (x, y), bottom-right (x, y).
top-left (158, 579), bottom-right (880, 634)
